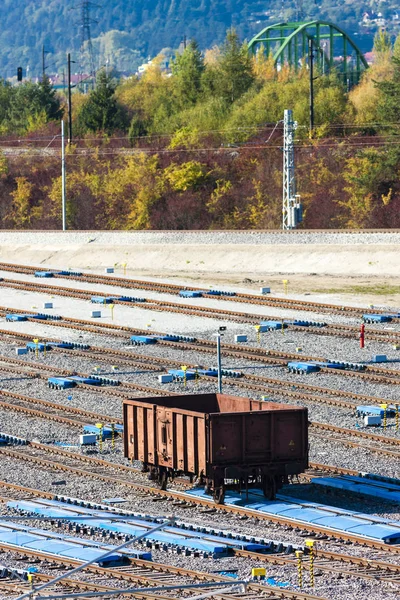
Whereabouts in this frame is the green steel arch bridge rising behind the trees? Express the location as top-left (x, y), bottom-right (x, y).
top-left (248, 21), bottom-right (368, 85)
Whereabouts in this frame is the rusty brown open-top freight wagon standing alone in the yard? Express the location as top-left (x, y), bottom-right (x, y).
top-left (124, 394), bottom-right (308, 503)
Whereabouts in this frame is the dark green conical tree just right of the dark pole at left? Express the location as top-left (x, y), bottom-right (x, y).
top-left (77, 70), bottom-right (126, 134)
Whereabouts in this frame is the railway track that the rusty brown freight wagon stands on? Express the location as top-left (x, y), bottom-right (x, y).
top-left (0, 446), bottom-right (400, 554)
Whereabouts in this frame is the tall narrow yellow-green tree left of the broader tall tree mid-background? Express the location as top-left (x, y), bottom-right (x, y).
top-left (172, 40), bottom-right (205, 106)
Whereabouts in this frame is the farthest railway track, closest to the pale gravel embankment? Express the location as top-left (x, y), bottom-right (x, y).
top-left (0, 263), bottom-right (397, 317)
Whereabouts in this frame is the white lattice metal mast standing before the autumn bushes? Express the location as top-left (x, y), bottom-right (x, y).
top-left (282, 110), bottom-right (303, 229)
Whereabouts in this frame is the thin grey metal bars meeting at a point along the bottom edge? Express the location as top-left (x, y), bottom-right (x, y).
top-left (36, 581), bottom-right (247, 600)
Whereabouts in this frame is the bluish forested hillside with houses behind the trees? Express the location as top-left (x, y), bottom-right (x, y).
top-left (0, 0), bottom-right (398, 78)
